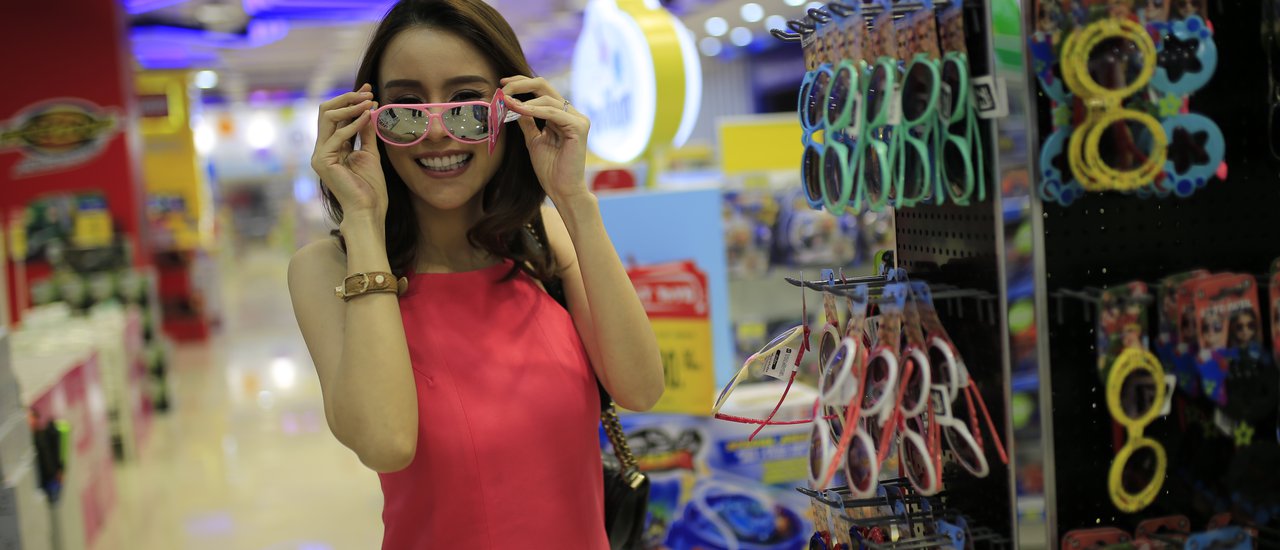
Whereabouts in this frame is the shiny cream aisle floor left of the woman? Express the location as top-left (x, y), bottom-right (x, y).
top-left (97, 251), bottom-right (381, 550)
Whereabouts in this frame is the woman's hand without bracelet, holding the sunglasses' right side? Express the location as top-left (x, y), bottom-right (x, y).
top-left (500, 75), bottom-right (591, 206)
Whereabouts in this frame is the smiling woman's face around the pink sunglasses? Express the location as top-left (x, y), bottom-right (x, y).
top-left (378, 27), bottom-right (507, 210)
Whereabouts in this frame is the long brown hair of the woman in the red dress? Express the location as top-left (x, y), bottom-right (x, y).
top-left (321, 0), bottom-right (556, 281)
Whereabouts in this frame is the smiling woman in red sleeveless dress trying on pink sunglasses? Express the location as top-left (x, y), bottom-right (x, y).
top-left (289, 0), bottom-right (663, 550)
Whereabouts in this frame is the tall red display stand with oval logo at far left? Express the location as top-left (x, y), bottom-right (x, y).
top-left (0, 0), bottom-right (151, 321)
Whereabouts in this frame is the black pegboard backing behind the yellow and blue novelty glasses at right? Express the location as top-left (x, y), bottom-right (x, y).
top-left (1039, 0), bottom-right (1280, 540)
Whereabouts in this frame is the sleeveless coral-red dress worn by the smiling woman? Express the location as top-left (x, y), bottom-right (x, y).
top-left (379, 261), bottom-right (609, 550)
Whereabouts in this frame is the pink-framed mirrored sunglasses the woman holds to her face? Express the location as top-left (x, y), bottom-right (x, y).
top-left (374, 90), bottom-right (520, 153)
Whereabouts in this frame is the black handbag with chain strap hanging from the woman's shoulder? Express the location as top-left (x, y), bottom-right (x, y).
top-left (527, 215), bottom-right (649, 550)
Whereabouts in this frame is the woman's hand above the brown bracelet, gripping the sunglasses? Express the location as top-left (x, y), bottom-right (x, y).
top-left (311, 83), bottom-right (387, 220)
